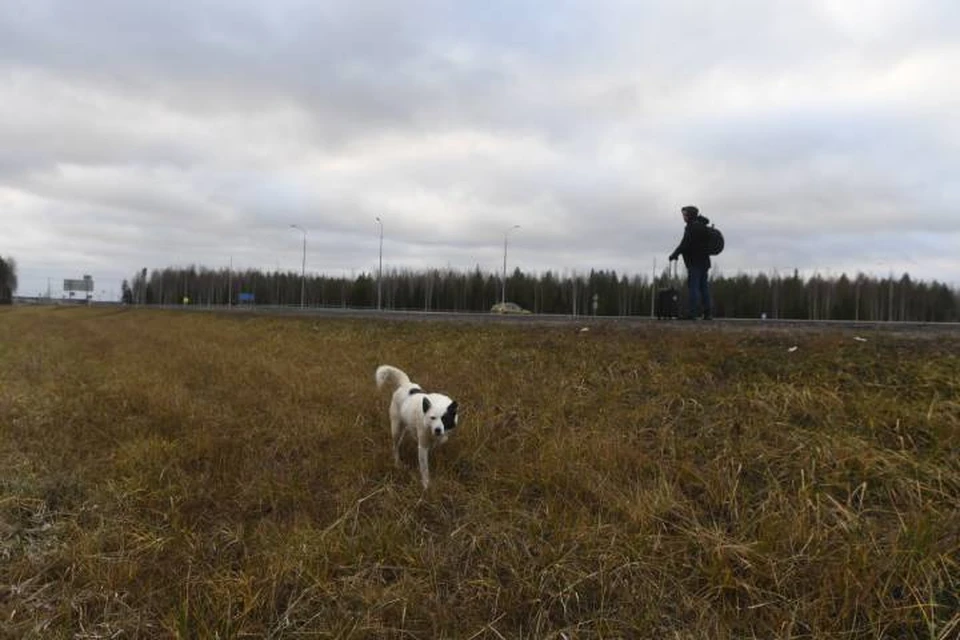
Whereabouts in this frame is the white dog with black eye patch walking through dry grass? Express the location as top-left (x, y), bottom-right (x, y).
top-left (375, 364), bottom-right (457, 489)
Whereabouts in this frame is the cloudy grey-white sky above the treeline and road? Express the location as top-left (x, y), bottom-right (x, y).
top-left (0, 0), bottom-right (960, 295)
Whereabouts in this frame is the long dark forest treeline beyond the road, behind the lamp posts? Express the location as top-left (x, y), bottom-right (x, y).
top-left (122, 267), bottom-right (960, 322)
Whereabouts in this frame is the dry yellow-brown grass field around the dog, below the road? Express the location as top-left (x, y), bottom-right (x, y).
top-left (0, 308), bottom-right (960, 640)
